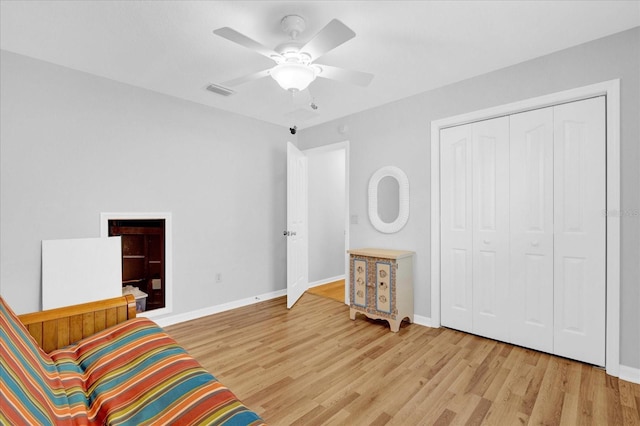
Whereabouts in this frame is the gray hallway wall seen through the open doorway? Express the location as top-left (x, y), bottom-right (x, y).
top-left (308, 149), bottom-right (345, 283)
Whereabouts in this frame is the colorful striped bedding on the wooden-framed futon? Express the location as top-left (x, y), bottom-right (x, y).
top-left (0, 298), bottom-right (264, 425)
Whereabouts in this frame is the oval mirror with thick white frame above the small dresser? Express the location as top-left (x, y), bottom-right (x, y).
top-left (369, 166), bottom-right (409, 234)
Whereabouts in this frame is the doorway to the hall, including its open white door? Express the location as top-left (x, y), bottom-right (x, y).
top-left (284, 141), bottom-right (349, 308)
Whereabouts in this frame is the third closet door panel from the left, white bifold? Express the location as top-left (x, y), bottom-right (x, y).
top-left (509, 107), bottom-right (553, 353)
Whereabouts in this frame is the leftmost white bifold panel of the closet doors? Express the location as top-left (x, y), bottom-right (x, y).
top-left (440, 125), bottom-right (473, 332)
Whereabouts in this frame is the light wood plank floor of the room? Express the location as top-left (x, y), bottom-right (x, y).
top-left (167, 293), bottom-right (640, 425)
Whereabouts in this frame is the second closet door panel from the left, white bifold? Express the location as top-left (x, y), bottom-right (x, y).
top-left (472, 117), bottom-right (509, 341)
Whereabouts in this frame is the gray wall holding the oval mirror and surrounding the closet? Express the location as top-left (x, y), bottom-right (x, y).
top-left (298, 28), bottom-right (640, 368)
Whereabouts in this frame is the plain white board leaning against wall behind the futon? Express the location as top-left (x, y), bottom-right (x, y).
top-left (42, 237), bottom-right (122, 309)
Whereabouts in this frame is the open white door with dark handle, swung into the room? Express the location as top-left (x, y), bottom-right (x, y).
top-left (285, 142), bottom-right (309, 309)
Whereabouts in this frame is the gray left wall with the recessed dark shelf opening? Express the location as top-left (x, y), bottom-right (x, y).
top-left (0, 51), bottom-right (289, 314)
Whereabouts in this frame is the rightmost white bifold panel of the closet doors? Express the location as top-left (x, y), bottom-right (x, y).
top-left (554, 97), bottom-right (606, 365)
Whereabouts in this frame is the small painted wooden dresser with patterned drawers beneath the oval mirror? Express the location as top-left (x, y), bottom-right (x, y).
top-left (348, 248), bottom-right (414, 333)
